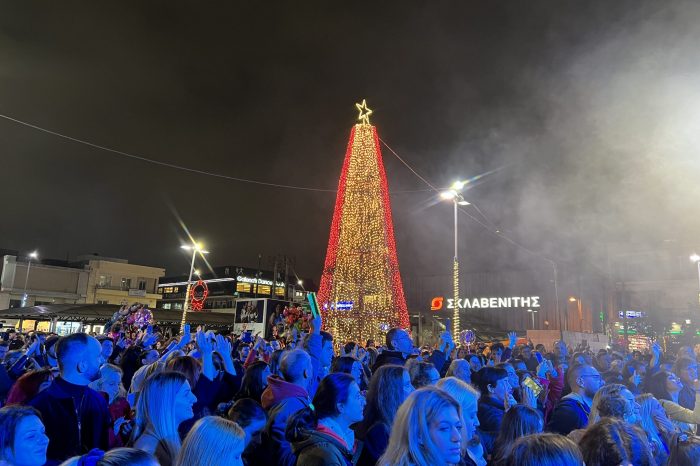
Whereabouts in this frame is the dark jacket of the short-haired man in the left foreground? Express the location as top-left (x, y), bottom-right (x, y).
top-left (29, 377), bottom-right (111, 464)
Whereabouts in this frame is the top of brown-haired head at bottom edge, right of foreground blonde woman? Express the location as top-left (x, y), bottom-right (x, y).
top-left (504, 434), bottom-right (588, 466)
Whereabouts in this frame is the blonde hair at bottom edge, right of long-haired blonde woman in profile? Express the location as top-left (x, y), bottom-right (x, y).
top-left (173, 416), bottom-right (245, 466)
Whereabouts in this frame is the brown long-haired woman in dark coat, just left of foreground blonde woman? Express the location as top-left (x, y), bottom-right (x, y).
top-left (355, 364), bottom-right (413, 466)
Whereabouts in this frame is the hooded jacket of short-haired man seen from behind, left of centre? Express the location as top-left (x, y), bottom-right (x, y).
top-left (261, 375), bottom-right (311, 466)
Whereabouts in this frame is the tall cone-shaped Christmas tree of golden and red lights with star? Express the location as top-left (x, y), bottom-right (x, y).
top-left (318, 100), bottom-right (409, 344)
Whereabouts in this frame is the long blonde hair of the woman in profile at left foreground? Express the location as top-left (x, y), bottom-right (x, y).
top-left (131, 372), bottom-right (187, 458)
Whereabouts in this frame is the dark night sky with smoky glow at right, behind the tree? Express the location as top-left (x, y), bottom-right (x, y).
top-left (0, 0), bottom-right (700, 281)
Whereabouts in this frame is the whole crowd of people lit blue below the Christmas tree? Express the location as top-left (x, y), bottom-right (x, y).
top-left (0, 308), bottom-right (700, 466)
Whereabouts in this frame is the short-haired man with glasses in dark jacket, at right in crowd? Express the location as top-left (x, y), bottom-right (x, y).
top-left (545, 364), bottom-right (604, 435)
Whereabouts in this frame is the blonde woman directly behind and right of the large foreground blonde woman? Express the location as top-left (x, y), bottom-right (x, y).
top-left (437, 374), bottom-right (486, 466)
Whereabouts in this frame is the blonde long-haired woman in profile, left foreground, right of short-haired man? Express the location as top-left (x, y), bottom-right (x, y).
top-left (132, 372), bottom-right (197, 466)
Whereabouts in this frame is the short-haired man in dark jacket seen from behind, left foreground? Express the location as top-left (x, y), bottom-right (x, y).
top-left (29, 333), bottom-right (111, 465)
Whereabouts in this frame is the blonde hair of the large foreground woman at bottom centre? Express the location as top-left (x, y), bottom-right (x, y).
top-left (377, 387), bottom-right (462, 466)
